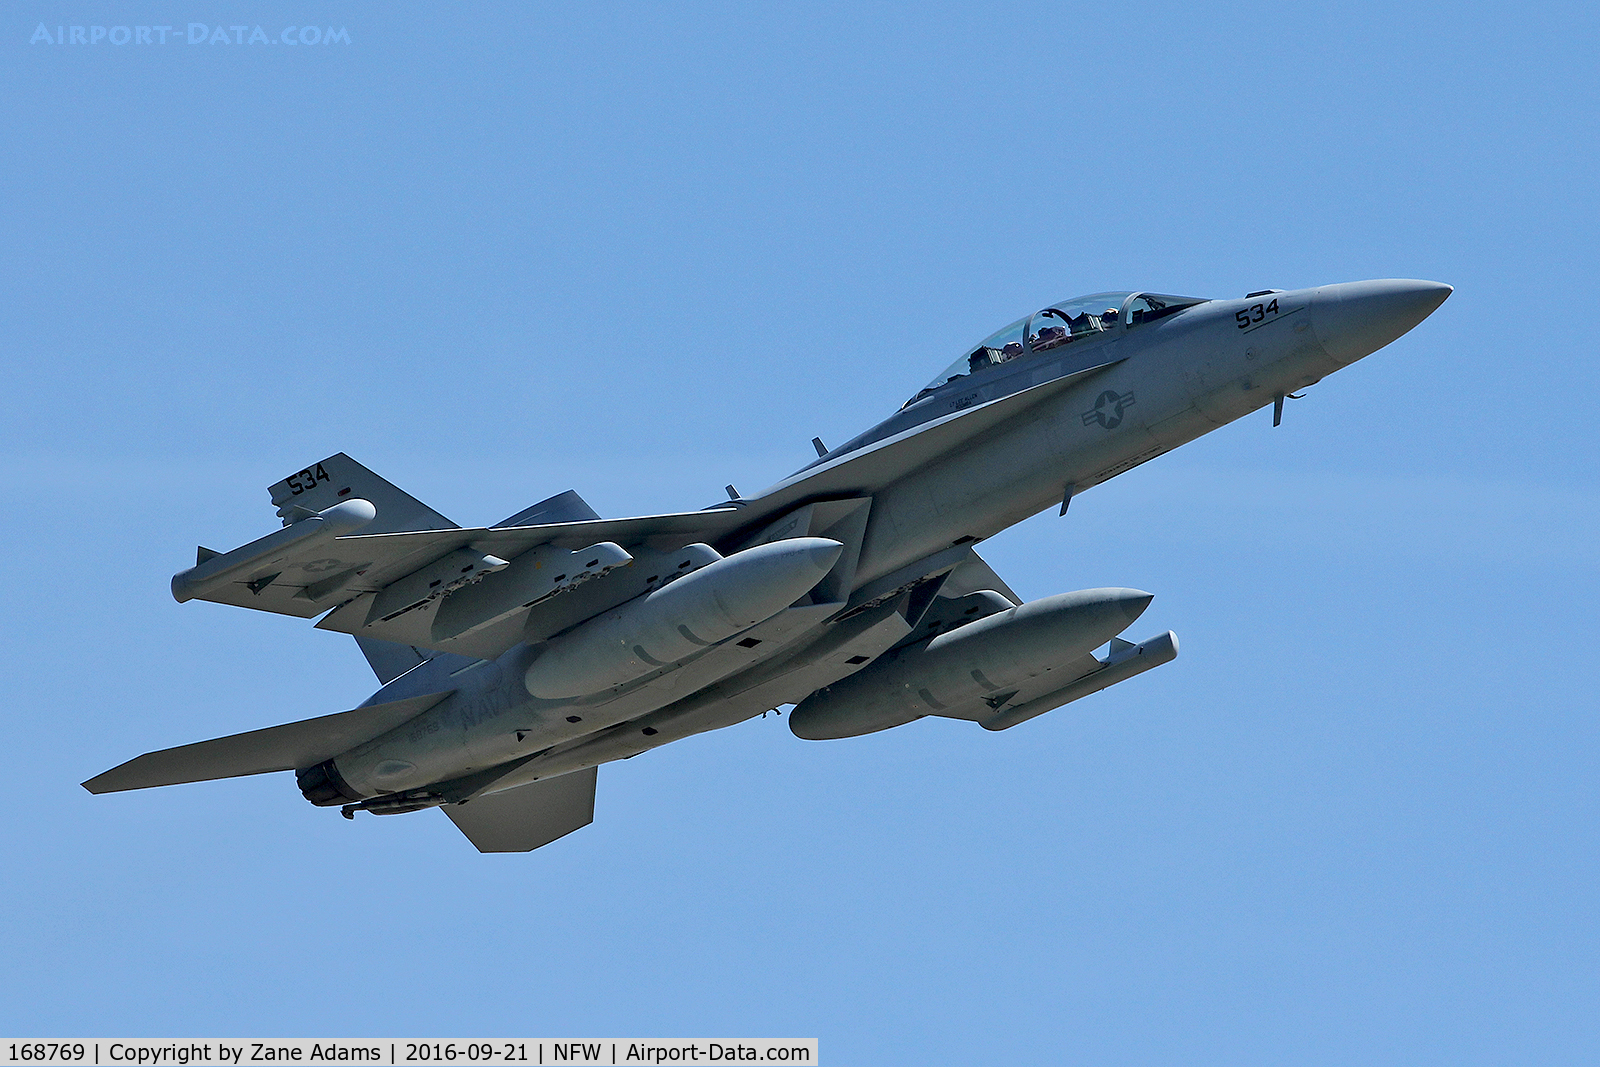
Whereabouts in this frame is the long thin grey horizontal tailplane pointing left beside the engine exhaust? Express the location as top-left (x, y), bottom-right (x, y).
top-left (83, 693), bottom-right (454, 796)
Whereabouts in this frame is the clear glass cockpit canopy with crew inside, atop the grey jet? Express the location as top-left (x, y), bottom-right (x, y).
top-left (906, 293), bottom-right (1205, 408)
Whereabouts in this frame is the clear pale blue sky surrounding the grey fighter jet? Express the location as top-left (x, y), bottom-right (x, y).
top-left (0, 0), bottom-right (1600, 1064)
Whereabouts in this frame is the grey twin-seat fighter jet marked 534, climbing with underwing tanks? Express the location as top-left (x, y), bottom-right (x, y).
top-left (83, 280), bottom-right (1451, 851)
